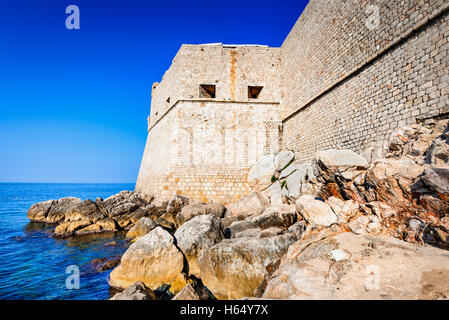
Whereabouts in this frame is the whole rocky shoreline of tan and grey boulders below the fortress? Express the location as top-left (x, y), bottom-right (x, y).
top-left (28, 120), bottom-right (449, 300)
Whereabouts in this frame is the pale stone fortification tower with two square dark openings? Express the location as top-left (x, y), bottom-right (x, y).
top-left (136, 44), bottom-right (280, 202)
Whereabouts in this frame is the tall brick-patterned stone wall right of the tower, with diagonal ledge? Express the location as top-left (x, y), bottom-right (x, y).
top-left (281, 0), bottom-right (449, 161)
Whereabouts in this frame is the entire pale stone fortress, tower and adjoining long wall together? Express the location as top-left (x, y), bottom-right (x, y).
top-left (136, 0), bottom-right (449, 202)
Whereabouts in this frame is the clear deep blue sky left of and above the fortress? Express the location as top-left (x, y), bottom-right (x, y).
top-left (0, 0), bottom-right (308, 182)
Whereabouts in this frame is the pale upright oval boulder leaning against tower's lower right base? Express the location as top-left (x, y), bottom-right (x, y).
top-left (248, 154), bottom-right (277, 191)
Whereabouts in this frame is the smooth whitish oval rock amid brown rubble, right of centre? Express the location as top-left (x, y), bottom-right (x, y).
top-left (296, 195), bottom-right (337, 227)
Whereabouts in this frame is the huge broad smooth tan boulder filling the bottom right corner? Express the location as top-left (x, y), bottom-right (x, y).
top-left (262, 233), bottom-right (449, 300)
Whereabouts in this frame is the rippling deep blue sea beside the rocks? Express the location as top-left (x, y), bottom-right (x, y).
top-left (0, 183), bottom-right (134, 300)
